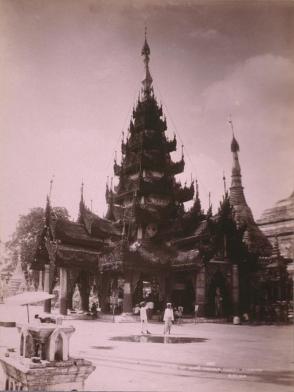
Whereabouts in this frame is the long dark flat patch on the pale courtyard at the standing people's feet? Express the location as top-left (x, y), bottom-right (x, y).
top-left (110, 335), bottom-right (207, 344)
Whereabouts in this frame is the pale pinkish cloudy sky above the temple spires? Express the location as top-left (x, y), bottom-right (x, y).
top-left (0, 0), bottom-right (294, 241)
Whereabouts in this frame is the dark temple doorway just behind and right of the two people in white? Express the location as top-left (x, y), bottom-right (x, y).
top-left (171, 272), bottom-right (195, 314)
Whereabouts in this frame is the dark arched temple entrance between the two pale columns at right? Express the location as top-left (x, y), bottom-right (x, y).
top-left (207, 270), bottom-right (230, 318)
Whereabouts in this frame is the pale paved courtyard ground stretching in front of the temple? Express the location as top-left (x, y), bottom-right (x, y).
top-left (0, 308), bottom-right (294, 392)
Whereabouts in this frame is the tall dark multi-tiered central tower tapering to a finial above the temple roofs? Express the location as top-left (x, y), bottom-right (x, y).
top-left (106, 37), bottom-right (194, 241)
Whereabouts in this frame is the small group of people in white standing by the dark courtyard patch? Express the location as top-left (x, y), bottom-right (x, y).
top-left (140, 302), bottom-right (184, 334)
